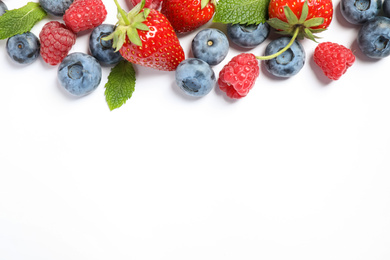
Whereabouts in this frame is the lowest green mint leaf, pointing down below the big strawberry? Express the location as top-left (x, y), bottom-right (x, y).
top-left (104, 60), bottom-right (135, 111)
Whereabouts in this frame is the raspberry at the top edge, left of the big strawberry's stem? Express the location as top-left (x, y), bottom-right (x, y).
top-left (63, 0), bottom-right (107, 33)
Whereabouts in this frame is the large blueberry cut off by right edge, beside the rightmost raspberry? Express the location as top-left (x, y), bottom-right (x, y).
top-left (357, 16), bottom-right (390, 59)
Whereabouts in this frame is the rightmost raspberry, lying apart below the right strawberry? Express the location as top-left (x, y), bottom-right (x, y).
top-left (314, 42), bottom-right (355, 80)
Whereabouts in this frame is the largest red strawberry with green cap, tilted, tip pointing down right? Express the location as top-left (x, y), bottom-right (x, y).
top-left (104, 0), bottom-right (185, 71)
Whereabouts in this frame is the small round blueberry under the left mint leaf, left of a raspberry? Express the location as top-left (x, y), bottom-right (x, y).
top-left (6, 32), bottom-right (40, 64)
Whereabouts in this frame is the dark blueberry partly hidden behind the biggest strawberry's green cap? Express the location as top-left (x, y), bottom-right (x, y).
top-left (89, 24), bottom-right (123, 64)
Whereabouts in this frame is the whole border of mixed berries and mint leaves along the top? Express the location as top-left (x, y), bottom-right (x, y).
top-left (0, 0), bottom-right (390, 110)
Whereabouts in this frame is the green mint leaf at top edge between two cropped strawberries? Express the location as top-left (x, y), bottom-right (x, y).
top-left (213, 0), bottom-right (269, 24)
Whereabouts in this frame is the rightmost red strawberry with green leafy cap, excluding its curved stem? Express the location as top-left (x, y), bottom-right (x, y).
top-left (268, 0), bottom-right (333, 40)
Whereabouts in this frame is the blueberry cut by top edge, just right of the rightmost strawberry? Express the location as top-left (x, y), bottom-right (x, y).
top-left (340, 0), bottom-right (382, 24)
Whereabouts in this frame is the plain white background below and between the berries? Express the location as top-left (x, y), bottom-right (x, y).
top-left (0, 0), bottom-right (390, 260)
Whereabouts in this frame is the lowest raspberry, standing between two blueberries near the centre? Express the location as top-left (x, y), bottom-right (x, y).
top-left (218, 53), bottom-right (260, 99)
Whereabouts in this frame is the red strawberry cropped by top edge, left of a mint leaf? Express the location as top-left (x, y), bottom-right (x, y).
top-left (161, 0), bottom-right (216, 33)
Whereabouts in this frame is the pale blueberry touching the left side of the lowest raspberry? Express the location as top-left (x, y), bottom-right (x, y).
top-left (175, 58), bottom-right (217, 97)
